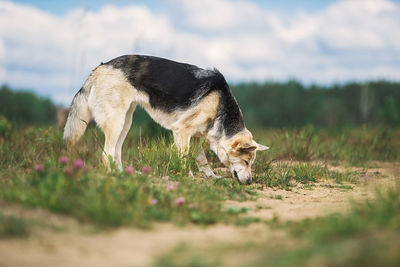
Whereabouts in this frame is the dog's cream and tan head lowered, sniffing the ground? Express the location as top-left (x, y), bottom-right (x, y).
top-left (218, 129), bottom-right (269, 184)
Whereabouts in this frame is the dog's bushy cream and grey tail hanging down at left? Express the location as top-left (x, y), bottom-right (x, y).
top-left (64, 75), bottom-right (93, 147)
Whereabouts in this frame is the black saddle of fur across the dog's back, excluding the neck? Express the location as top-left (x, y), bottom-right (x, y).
top-left (103, 55), bottom-right (226, 112)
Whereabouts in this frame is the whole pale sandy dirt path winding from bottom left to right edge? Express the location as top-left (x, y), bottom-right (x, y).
top-left (0, 163), bottom-right (400, 267)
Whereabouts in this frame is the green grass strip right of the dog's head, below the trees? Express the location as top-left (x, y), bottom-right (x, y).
top-left (254, 126), bottom-right (400, 165)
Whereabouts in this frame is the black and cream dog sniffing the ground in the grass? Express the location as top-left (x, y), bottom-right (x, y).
top-left (64, 55), bottom-right (268, 184)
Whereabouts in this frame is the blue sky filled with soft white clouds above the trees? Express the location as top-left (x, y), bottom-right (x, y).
top-left (0, 0), bottom-right (400, 105)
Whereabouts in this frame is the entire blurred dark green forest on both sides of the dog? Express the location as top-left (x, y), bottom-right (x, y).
top-left (0, 81), bottom-right (400, 130)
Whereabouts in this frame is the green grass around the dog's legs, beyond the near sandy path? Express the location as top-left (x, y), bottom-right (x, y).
top-left (0, 124), bottom-right (400, 227)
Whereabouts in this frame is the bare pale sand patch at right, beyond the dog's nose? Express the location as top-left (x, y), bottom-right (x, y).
top-left (227, 163), bottom-right (400, 223)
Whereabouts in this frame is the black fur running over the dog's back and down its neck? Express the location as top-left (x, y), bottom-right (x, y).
top-left (104, 55), bottom-right (244, 136)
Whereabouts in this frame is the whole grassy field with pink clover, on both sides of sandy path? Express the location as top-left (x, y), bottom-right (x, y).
top-left (0, 123), bottom-right (400, 266)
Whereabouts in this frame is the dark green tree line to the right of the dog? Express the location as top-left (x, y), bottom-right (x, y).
top-left (231, 81), bottom-right (400, 127)
